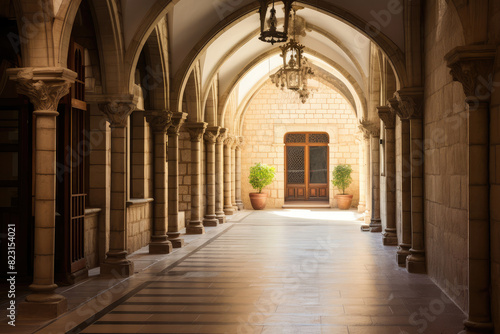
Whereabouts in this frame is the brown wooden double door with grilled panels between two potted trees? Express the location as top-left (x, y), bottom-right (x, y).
top-left (285, 132), bottom-right (330, 201)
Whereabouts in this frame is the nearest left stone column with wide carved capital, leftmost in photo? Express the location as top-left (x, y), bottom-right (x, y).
top-left (7, 68), bottom-right (76, 318)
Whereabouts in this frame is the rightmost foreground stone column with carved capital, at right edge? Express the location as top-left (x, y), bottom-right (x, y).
top-left (445, 45), bottom-right (498, 333)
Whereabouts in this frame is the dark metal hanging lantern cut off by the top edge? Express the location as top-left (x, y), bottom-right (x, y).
top-left (259, 0), bottom-right (294, 45)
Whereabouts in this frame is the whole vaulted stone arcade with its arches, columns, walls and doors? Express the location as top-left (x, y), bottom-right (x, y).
top-left (0, 0), bottom-right (500, 333)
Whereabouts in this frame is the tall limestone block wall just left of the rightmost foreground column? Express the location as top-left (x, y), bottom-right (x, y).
top-left (424, 0), bottom-right (468, 310)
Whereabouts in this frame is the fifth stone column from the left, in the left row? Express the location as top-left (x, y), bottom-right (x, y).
top-left (186, 122), bottom-right (207, 234)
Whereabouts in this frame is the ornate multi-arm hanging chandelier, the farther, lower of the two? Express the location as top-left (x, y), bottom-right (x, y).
top-left (271, 10), bottom-right (314, 103)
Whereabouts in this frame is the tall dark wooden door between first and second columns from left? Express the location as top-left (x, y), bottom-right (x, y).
top-left (56, 43), bottom-right (89, 283)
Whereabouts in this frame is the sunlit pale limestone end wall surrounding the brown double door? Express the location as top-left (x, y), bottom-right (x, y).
top-left (242, 82), bottom-right (361, 208)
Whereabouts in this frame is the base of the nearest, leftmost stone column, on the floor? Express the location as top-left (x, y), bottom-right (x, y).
top-left (18, 293), bottom-right (68, 319)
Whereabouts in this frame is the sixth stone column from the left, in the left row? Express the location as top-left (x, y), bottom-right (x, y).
top-left (203, 126), bottom-right (220, 226)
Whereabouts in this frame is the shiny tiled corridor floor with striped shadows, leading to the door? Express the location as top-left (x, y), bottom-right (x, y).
top-left (14, 210), bottom-right (465, 334)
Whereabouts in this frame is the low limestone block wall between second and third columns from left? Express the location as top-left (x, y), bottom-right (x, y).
top-left (127, 201), bottom-right (153, 254)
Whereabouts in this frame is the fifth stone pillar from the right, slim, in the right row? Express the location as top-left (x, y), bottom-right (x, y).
top-left (370, 125), bottom-right (382, 233)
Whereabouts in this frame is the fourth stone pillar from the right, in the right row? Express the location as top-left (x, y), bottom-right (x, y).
top-left (377, 106), bottom-right (398, 246)
